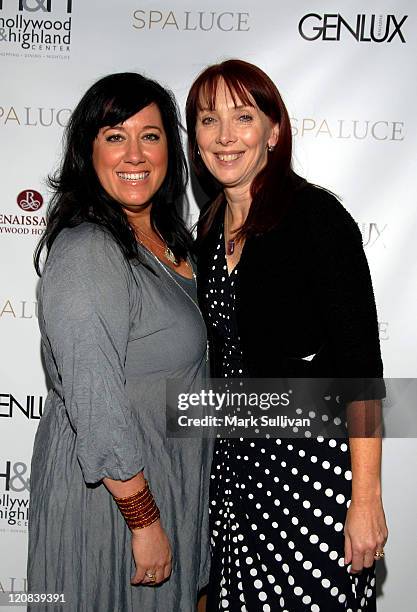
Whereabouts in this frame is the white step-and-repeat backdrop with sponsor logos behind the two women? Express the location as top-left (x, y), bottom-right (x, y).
top-left (0, 0), bottom-right (417, 612)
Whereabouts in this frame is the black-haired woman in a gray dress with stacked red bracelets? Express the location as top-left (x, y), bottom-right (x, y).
top-left (28, 73), bottom-right (210, 612)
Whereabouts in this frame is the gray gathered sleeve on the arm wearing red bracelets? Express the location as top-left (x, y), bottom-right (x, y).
top-left (40, 224), bottom-right (143, 483)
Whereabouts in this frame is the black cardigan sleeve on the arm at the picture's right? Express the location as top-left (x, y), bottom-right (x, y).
top-left (310, 191), bottom-right (385, 401)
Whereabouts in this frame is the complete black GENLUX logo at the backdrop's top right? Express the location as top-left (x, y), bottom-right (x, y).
top-left (298, 13), bottom-right (408, 43)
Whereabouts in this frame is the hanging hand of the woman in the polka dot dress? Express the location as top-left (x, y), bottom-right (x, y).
top-left (344, 496), bottom-right (388, 574)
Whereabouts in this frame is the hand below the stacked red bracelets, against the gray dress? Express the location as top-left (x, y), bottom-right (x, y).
top-left (131, 519), bottom-right (172, 585)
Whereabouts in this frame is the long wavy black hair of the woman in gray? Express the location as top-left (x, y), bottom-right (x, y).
top-left (34, 72), bottom-right (192, 276)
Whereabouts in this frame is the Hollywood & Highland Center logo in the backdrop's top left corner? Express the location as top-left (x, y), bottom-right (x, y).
top-left (0, 0), bottom-right (72, 59)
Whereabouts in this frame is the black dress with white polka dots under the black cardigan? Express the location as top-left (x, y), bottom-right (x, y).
top-left (205, 228), bottom-right (376, 612)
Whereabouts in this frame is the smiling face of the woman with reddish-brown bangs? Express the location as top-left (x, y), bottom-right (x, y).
top-left (196, 80), bottom-right (279, 193)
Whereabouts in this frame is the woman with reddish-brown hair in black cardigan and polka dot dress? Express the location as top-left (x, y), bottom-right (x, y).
top-left (186, 60), bottom-right (387, 612)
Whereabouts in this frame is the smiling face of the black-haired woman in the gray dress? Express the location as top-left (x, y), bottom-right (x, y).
top-left (93, 104), bottom-right (168, 212)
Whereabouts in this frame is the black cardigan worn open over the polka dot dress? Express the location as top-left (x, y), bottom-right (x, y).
top-left (198, 183), bottom-right (384, 399)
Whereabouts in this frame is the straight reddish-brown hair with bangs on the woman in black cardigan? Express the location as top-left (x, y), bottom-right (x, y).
top-left (186, 59), bottom-right (306, 238)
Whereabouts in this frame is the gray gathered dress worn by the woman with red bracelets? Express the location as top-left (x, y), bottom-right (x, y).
top-left (28, 223), bottom-right (211, 612)
